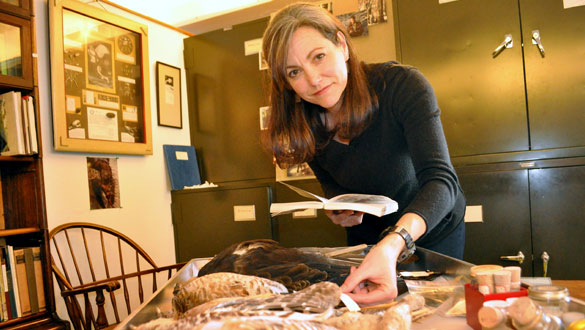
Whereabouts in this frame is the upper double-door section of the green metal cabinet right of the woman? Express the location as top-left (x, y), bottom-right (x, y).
top-left (395, 0), bottom-right (585, 161)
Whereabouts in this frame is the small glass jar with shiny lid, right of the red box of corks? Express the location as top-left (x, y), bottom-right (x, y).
top-left (528, 285), bottom-right (569, 317)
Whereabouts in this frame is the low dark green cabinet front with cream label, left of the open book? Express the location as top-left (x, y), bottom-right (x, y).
top-left (171, 184), bottom-right (273, 262)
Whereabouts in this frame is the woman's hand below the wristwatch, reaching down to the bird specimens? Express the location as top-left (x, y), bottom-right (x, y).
top-left (341, 238), bottom-right (400, 306)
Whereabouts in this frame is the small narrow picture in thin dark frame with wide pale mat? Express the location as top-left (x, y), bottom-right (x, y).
top-left (156, 62), bottom-right (183, 128)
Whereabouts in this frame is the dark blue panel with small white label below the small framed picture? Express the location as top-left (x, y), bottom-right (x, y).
top-left (163, 144), bottom-right (201, 190)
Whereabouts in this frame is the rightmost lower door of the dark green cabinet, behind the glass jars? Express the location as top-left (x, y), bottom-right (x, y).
top-left (530, 166), bottom-right (585, 280)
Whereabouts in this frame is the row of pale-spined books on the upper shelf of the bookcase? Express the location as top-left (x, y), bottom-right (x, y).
top-left (0, 91), bottom-right (39, 156)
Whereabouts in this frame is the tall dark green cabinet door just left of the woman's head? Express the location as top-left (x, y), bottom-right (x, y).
top-left (184, 19), bottom-right (274, 183)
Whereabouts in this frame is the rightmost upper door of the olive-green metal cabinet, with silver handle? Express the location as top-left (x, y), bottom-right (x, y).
top-left (520, 0), bottom-right (585, 150)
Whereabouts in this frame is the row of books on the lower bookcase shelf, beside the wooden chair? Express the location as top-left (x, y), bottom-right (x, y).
top-left (0, 245), bottom-right (46, 321)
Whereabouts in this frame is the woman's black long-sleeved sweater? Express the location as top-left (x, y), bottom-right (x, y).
top-left (309, 62), bottom-right (465, 246)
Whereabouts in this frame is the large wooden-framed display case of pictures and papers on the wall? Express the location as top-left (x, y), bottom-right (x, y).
top-left (49, 0), bottom-right (152, 155)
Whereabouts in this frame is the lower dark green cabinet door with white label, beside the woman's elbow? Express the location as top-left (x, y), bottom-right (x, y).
top-left (458, 167), bottom-right (532, 276)
